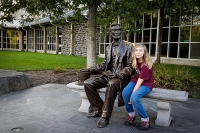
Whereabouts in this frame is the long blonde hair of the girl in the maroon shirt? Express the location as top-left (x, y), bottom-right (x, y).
top-left (132, 43), bottom-right (153, 69)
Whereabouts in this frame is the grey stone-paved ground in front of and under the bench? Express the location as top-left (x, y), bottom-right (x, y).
top-left (0, 84), bottom-right (200, 133)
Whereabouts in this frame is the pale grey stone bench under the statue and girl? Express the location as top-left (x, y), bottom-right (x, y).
top-left (66, 82), bottom-right (188, 127)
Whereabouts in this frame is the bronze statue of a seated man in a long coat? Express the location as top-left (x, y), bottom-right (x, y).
top-left (79, 23), bottom-right (134, 128)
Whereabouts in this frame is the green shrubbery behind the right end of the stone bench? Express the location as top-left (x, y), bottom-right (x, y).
top-left (154, 64), bottom-right (198, 95)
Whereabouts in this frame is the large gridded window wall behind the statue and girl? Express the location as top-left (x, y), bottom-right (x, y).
top-left (100, 8), bottom-right (200, 59)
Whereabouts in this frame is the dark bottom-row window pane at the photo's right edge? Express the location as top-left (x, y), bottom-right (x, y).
top-left (190, 43), bottom-right (200, 59)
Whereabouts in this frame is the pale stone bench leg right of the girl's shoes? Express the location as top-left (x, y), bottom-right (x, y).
top-left (155, 101), bottom-right (172, 127)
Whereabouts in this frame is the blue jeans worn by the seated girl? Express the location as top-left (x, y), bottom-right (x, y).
top-left (122, 82), bottom-right (151, 118)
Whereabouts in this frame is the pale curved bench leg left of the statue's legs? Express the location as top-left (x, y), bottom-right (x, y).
top-left (78, 91), bottom-right (90, 113)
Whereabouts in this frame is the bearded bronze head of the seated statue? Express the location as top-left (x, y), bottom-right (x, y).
top-left (110, 23), bottom-right (122, 39)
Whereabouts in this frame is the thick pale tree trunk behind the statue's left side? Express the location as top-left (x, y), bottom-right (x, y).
top-left (86, 0), bottom-right (98, 68)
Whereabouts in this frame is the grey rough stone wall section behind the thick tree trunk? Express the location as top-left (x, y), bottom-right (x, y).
top-left (61, 23), bottom-right (100, 56)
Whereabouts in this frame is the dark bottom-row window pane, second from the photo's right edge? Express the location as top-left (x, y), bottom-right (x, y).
top-left (179, 43), bottom-right (189, 58)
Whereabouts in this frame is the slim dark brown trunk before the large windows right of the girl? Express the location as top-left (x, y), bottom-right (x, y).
top-left (157, 7), bottom-right (164, 63)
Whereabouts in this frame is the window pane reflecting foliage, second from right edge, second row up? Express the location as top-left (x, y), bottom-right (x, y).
top-left (180, 26), bottom-right (190, 42)
